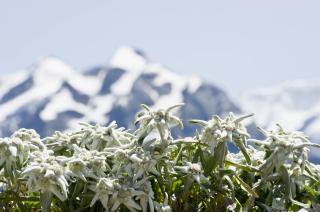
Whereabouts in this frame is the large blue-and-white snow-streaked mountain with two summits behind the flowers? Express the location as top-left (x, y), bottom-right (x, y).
top-left (0, 47), bottom-right (240, 136)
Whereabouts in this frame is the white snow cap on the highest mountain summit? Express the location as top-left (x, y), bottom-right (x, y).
top-left (110, 46), bottom-right (147, 73)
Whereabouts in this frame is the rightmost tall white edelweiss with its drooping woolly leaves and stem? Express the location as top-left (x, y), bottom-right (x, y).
top-left (251, 124), bottom-right (320, 209)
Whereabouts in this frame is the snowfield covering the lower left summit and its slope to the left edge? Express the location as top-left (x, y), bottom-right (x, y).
top-left (0, 57), bottom-right (99, 122)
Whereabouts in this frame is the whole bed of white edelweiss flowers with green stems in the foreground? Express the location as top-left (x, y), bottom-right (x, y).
top-left (0, 104), bottom-right (320, 212)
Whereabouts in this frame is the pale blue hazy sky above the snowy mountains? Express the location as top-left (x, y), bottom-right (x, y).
top-left (0, 0), bottom-right (320, 95)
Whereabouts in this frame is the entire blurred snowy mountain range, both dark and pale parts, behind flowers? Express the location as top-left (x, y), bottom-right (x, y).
top-left (0, 47), bottom-right (320, 161)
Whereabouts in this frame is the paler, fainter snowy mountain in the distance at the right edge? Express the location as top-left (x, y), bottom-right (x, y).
top-left (241, 80), bottom-right (320, 160)
